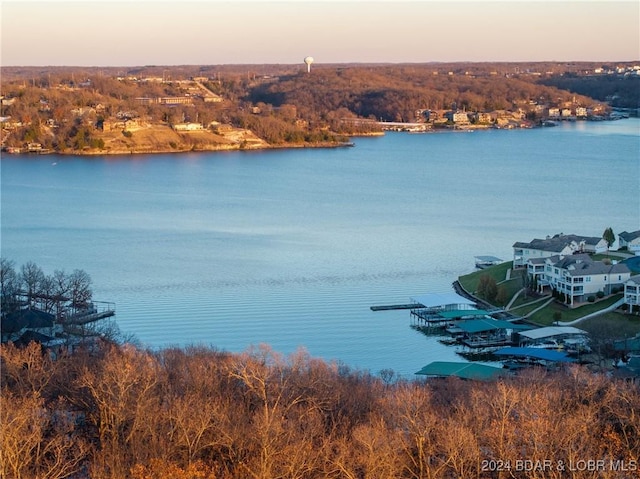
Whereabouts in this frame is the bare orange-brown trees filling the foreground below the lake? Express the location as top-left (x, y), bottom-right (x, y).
top-left (0, 343), bottom-right (640, 479)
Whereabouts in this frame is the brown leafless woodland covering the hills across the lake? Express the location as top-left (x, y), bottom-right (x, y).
top-left (0, 64), bottom-right (608, 152)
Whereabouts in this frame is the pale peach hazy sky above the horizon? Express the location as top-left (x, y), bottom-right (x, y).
top-left (0, 0), bottom-right (640, 66)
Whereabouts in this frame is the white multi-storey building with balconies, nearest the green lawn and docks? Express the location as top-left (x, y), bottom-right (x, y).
top-left (527, 254), bottom-right (631, 305)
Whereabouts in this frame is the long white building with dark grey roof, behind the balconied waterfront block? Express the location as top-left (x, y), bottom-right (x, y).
top-left (513, 233), bottom-right (608, 269)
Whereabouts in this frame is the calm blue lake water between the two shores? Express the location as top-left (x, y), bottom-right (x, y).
top-left (1, 119), bottom-right (640, 377)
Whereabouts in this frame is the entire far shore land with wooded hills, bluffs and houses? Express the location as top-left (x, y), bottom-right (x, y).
top-left (0, 62), bottom-right (640, 155)
